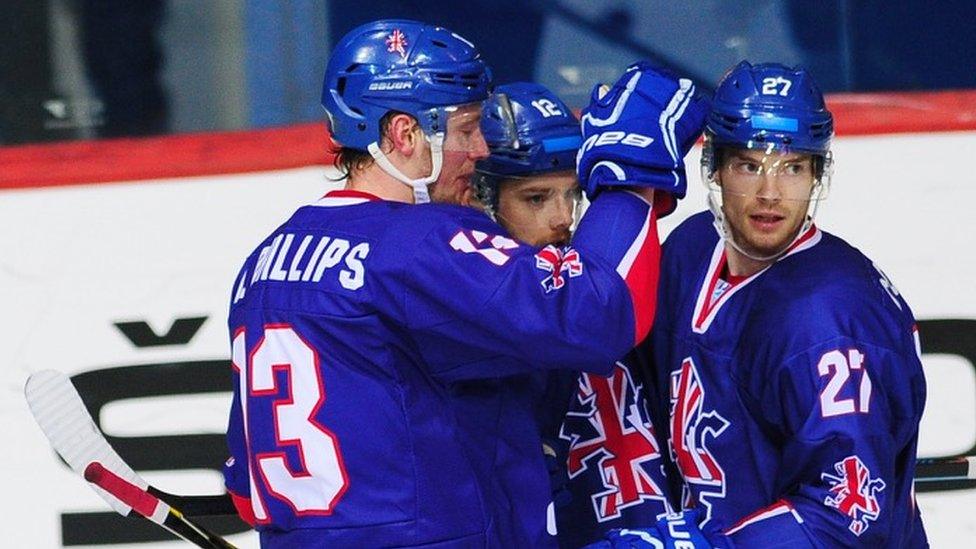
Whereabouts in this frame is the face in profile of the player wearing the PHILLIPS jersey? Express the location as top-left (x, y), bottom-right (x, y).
top-left (430, 103), bottom-right (488, 205)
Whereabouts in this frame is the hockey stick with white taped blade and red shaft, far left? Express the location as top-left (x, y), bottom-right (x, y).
top-left (24, 370), bottom-right (234, 548)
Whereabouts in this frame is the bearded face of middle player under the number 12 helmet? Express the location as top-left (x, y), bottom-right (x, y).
top-left (496, 171), bottom-right (580, 247)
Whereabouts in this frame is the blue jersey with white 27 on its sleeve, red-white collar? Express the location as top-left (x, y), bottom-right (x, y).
top-left (645, 213), bottom-right (926, 548)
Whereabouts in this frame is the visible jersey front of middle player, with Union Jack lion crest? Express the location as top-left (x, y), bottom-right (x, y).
top-left (543, 361), bottom-right (671, 548)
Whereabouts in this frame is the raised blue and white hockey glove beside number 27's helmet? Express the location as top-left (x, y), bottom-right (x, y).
top-left (576, 62), bottom-right (709, 208)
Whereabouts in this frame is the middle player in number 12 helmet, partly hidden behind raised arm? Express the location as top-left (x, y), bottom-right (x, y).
top-left (474, 82), bottom-right (683, 547)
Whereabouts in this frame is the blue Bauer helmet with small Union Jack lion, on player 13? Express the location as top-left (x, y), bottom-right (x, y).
top-left (322, 19), bottom-right (491, 150)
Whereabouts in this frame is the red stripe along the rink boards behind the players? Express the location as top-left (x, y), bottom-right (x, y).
top-left (0, 90), bottom-right (976, 190)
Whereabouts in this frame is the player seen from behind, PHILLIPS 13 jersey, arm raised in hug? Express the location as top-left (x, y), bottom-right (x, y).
top-left (225, 20), bottom-right (705, 547)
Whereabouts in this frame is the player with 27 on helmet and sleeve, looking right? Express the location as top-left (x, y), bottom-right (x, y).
top-left (596, 62), bottom-right (927, 548)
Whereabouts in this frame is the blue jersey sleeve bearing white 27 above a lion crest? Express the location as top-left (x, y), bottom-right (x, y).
top-left (715, 334), bottom-right (925, 547)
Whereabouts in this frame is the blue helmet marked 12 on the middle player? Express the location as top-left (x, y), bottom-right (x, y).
top-left (473, 82), bottom-right (582, 214)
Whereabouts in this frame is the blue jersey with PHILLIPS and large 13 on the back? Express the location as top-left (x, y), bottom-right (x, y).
top-left (224, 186), bottom-right (657, 547)
